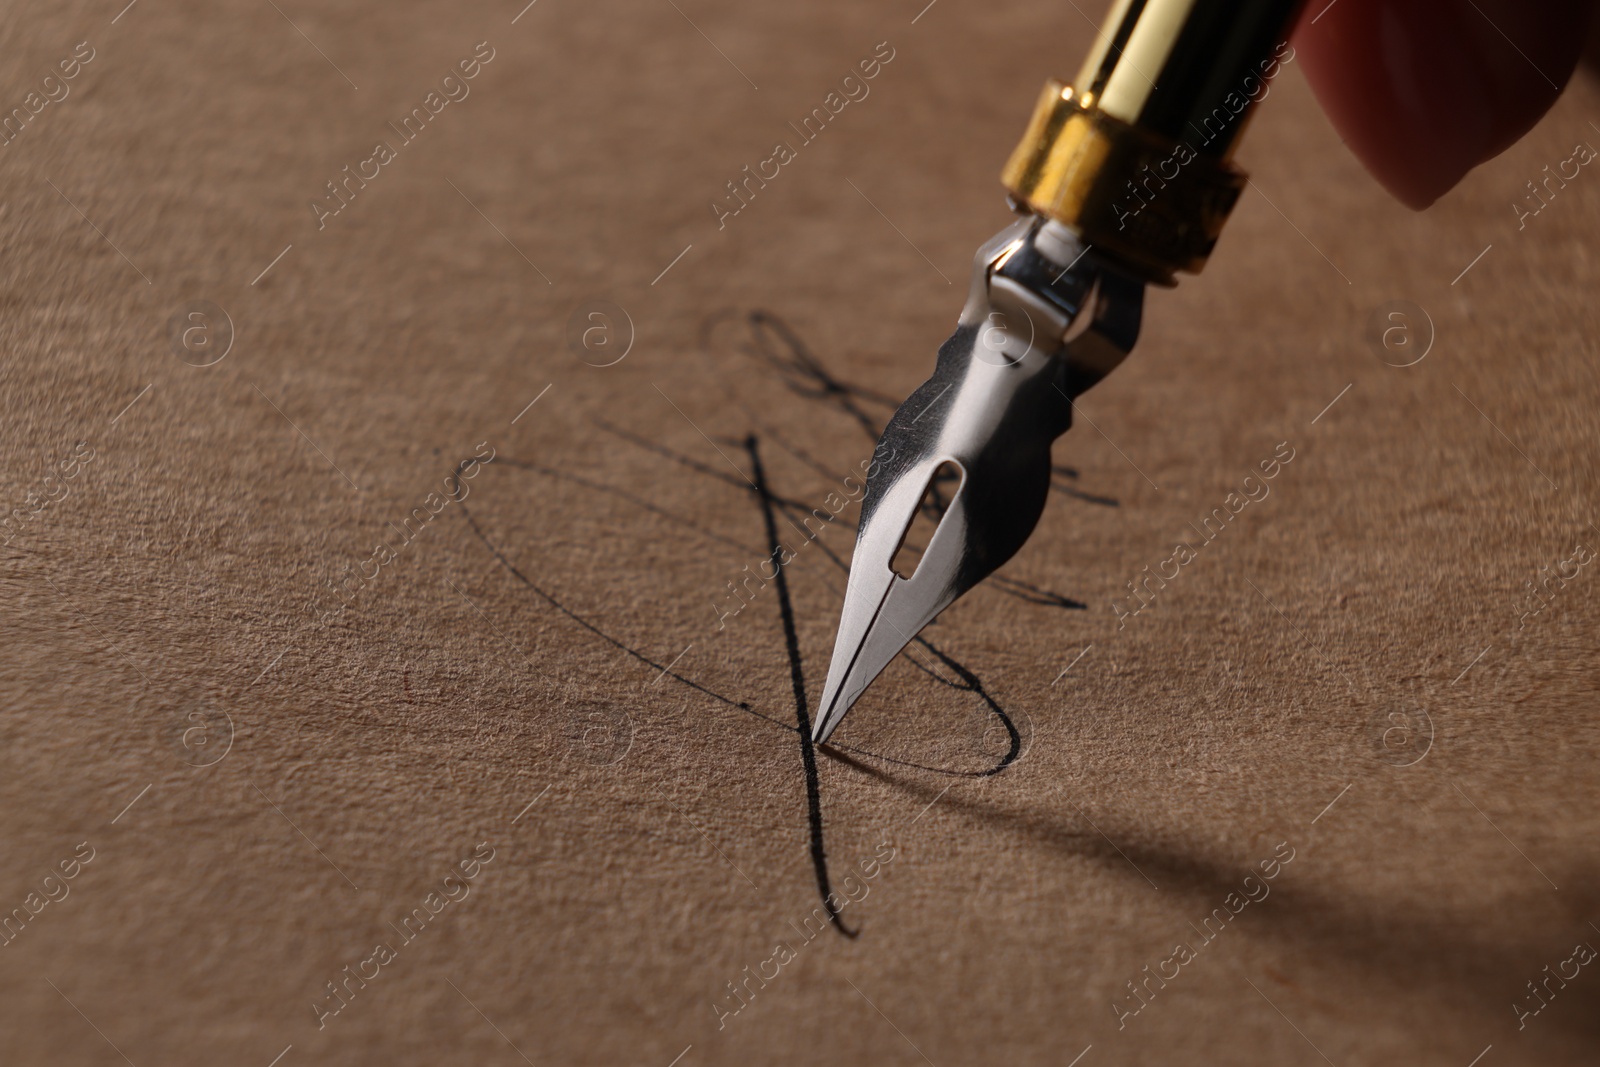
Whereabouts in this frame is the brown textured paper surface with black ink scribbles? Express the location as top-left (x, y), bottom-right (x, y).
top-left (0, 0), bottom-right (1600, 1067)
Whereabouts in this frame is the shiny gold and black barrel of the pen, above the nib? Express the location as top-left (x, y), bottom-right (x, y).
top-left (1000, 0), bottom-right (1301, 285)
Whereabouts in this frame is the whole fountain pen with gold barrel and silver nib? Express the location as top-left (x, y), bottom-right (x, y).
top-left (811, 0), bottom-right (1301, 744)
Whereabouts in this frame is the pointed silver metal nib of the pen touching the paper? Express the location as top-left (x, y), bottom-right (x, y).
top-left (811, 218), bottom-right (1144, 744)
